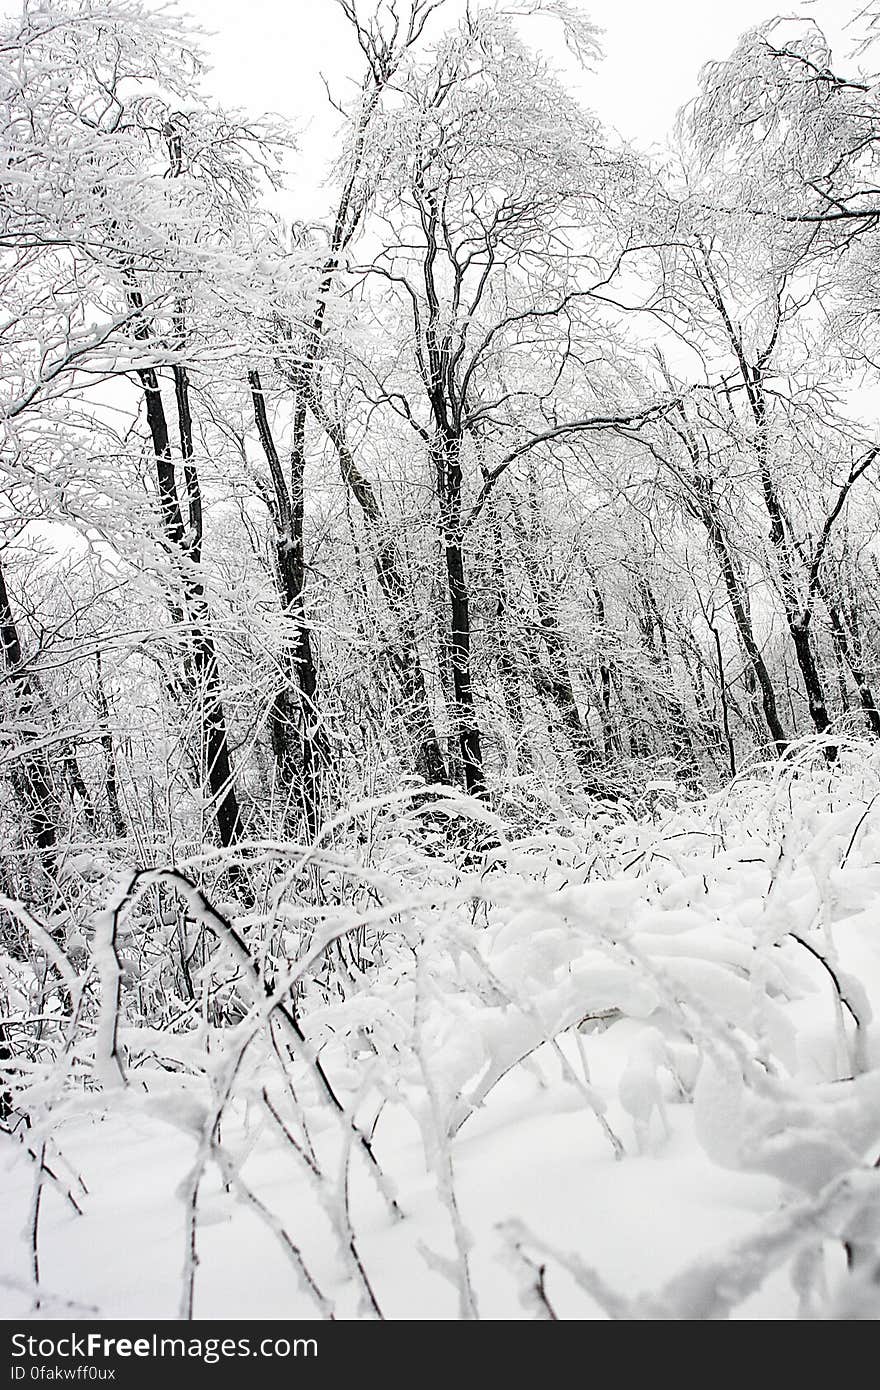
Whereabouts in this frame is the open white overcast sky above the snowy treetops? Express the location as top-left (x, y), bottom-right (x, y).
top-left (182, 0), bottom-right (861, 205)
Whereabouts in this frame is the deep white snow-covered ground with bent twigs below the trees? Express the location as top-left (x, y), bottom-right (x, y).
top-left (0, 745), bottom-right (880, 1319)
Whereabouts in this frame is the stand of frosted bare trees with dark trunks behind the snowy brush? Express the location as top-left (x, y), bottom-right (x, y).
top-left (0, 0), bottom-right (880, 910)
